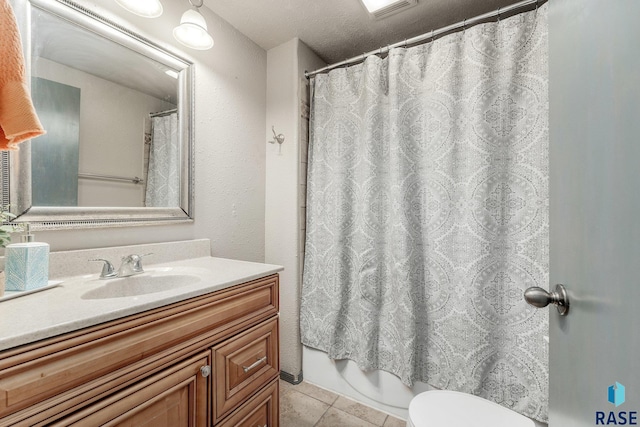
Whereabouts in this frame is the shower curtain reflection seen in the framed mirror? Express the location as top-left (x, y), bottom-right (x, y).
top-left (145, 113), bottom-right (180, 207)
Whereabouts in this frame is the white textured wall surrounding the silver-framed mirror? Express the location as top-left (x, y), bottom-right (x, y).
top-left (10, 0), bottom-right (266, 261)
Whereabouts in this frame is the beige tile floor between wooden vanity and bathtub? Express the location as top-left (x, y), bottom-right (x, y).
top-left (280, 380), bottom-right (406, 427)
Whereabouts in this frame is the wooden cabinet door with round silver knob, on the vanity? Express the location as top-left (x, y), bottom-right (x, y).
top-left (53, 353), bottom-right (210, 427)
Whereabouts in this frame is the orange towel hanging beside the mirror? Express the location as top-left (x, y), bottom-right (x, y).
top-left (0, 0), bottom-right (45, 150)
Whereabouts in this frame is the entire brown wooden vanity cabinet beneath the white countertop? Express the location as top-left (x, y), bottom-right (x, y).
top-left (0, 275), bottom-right (279, 427)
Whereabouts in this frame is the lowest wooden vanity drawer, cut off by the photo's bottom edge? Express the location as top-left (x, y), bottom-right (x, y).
top-left (217, 380), bottom-right (279, 427)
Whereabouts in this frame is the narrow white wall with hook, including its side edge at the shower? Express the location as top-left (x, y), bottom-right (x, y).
top-left (265, 38), bottom-right (324, 382)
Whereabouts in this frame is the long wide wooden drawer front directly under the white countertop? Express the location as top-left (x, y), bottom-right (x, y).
top-left (0, 276), bottom-right (278, 425)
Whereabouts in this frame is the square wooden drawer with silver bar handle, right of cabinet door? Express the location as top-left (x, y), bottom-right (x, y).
top-left (213, 317), bottom-right (280, 425)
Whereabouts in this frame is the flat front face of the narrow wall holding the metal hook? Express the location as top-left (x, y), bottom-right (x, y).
top-left (265, 39), bottom-right (302, 378)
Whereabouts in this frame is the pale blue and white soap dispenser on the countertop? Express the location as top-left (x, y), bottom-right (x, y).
top-left (5, 224), bottom-right (49, 291)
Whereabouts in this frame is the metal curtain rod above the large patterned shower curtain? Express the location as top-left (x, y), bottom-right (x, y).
top-left (304, 0), bottom-right (547, 78)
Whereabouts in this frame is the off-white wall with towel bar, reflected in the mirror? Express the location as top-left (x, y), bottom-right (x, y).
top-left (32, 58), bottom-right (176, 207)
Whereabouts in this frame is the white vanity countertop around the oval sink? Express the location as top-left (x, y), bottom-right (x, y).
top-left (0, 257), bottom-right (283, 351)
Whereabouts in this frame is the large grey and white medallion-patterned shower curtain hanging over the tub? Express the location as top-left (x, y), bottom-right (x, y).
top-left (301, 5), bottom-right (549, 421)
